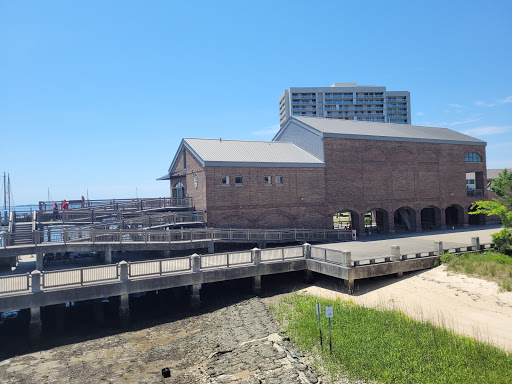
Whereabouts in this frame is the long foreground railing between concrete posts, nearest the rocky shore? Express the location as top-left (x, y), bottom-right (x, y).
top-left (0, 240), bottom-right (493, 295)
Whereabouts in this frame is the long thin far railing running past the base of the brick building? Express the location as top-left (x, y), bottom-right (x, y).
top-left (1, 227), bottom-right (352, 248)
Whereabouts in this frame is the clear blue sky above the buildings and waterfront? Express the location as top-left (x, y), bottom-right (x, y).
top-left (0, 0), bottom-right (512, 204)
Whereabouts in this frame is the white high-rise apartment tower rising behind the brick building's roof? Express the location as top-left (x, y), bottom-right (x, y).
top-left (279, 83), bottom-right (411, 126)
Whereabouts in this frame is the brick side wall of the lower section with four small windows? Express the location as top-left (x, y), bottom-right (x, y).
top-left (206, 167), bottom-right (325, 228)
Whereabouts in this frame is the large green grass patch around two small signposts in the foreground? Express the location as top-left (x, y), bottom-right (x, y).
top-left (274, 293), bottom-right (512, 384)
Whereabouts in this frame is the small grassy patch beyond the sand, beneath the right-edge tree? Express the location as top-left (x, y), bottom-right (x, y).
top-left (441, 251), bottom-right (512, 292)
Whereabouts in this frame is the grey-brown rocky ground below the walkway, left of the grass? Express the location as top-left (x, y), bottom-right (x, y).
top-left (0, 298), bottom-right (318, 384)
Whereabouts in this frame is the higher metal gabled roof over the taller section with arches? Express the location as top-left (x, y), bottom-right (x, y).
top-left (274, 116), bottom-right (487, 145)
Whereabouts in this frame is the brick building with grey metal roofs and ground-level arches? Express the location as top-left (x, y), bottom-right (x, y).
top-left (161, 117), bottom-right (487, 233)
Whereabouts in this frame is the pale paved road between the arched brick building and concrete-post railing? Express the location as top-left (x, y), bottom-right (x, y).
top-left (320, 226), bottom-right (500, 260)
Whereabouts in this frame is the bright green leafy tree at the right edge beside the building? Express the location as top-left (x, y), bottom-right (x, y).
top-left (470, 180), bottom-right (512, 255)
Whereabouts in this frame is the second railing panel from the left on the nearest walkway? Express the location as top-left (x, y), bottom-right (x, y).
top-left (42, 264), bottom-right (119, 288)
